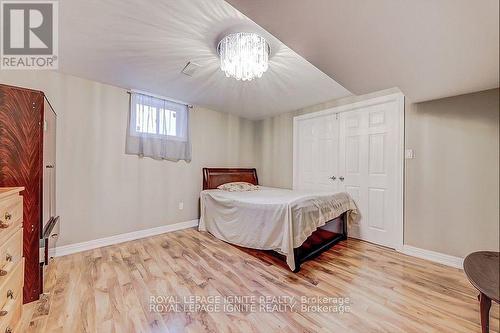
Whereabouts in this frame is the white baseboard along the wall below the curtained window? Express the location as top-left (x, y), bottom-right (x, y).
top-left (54, 220), bottom-right (198, 257)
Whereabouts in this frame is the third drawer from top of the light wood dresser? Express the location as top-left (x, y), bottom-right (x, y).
top-left (0, 259), bottom-right (24, 333)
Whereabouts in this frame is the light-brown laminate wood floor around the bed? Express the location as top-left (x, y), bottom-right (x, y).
top-left (19, 229), bottom-right (499, 333)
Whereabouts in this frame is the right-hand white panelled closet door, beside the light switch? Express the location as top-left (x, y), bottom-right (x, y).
top-left (339, 101), bottom-right (400, 248)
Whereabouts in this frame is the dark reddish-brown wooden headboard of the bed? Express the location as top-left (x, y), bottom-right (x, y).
top-left (203, 168), bottom-right (259, 190)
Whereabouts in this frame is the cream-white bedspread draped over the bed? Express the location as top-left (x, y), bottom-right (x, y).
top-left (199, 186), bottom-right (357, 270)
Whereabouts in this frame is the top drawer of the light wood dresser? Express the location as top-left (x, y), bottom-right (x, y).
top-left (0, 196), bottom-right (23, 243)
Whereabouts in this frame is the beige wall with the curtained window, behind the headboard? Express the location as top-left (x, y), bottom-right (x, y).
top-left (0, 71), bottom-right (255, 245)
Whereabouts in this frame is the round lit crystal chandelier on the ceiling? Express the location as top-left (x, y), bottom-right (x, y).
top-left (217, 32), bottom-right (270, 81)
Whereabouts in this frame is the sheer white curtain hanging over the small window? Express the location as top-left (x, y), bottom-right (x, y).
top-left (125, 92), bottom-right (191, 162)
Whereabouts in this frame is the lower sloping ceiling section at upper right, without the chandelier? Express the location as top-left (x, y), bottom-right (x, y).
top-left (227, 0), bottom-right (499, 102)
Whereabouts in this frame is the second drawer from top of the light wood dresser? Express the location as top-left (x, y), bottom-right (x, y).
top-left (0, 228), bottom-right (23, 286)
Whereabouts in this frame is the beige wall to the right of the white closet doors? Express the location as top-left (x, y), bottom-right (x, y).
top-left (405, 89), bottom-right (500, 257)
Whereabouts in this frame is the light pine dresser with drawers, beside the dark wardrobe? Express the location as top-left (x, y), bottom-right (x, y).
top-left (0, 187), bottom-right (24, 333)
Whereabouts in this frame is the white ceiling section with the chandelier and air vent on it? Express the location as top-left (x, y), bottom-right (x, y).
top-left (59, 0), bottom-right (350, 119)
